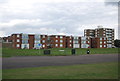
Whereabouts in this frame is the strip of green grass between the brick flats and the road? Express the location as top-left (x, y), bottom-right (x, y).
top-left (2, 48), bottom-right (120, 57)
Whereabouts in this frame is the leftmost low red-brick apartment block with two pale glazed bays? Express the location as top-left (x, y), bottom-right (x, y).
top-left (6, 33), bottom-right (48, 49)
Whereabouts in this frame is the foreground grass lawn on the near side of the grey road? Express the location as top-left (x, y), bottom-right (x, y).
top-left (3, 62), bottom-right (118, 79)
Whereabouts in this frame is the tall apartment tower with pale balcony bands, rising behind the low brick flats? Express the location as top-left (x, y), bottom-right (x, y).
top-left (84, 26), bottom-right (114, 48)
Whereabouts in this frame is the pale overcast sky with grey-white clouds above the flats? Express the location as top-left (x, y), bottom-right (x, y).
top-left (0, 0), bottom-right (118, 39)
